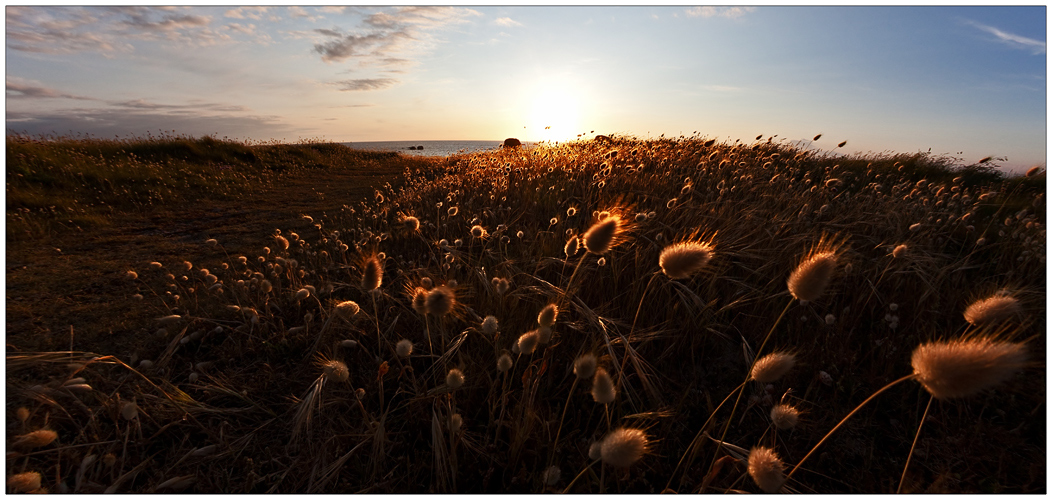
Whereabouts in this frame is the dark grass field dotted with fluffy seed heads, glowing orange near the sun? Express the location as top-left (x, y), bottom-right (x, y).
top-left (6, 136), bottom-right (1047, 494)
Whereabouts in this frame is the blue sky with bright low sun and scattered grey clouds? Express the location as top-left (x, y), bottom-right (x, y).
top-left (5, 5), bottom-right (1047, 169)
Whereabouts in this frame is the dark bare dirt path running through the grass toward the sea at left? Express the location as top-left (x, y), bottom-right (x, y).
top-left (6, 164), bottom-right (401, 356)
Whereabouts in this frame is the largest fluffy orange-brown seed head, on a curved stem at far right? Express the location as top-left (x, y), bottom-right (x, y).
top-left (910, 337), bottom-right (1027, 399)
